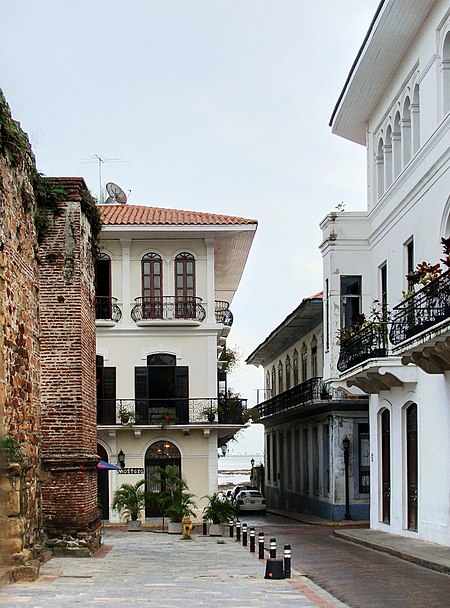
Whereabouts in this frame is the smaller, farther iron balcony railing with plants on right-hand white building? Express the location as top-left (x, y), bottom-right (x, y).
top-left (337, 322), bottom-right (388, 372)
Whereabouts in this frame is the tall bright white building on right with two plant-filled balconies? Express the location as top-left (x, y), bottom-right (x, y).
top-left (321, 0), bottom-right (450, 545)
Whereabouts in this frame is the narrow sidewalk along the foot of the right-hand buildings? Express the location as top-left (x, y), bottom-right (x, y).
top-left (271, 510), bottom-right (450, 576)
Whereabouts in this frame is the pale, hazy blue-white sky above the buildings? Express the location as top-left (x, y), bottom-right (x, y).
top-left (0, 0), bottom-right (379, 452)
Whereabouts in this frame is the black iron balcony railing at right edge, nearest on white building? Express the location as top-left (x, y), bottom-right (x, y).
top-left (389, 270), bottom-right (450, 344)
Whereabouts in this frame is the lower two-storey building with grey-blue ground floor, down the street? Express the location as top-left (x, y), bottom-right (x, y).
top-left (247, 293), bottom-right (370, 521)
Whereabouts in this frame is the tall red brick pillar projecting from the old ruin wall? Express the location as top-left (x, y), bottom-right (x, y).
top-left (39, 178), bottom-right (100, 555)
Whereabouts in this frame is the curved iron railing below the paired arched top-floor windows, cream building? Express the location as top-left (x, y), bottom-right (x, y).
top-left (131, 296), bottom-right (206, 322)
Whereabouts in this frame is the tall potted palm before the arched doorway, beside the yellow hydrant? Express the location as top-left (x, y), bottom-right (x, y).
top-left (155, 465), bottom-right (196, 534)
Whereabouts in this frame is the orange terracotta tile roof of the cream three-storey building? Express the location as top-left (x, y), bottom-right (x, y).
top-left (98, 205), bottom-right (258, 226)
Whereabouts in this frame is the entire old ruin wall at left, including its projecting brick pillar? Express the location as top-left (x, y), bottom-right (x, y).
top-left (0, 91), bottom-right (100, 582)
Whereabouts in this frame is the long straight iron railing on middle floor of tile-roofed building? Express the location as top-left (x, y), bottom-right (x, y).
top-left (97, 397), bottom-right (247, 426)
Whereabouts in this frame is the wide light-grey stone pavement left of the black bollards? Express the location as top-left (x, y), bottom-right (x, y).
top-left (0, 530), bottom-right (344, 608)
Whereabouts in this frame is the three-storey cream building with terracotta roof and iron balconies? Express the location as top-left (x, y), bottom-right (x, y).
top-left (96, 204), bottom-right (257, 521)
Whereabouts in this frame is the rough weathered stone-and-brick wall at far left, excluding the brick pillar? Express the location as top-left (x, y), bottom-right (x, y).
top-left (0, 123), bottom-right (42, 579)
